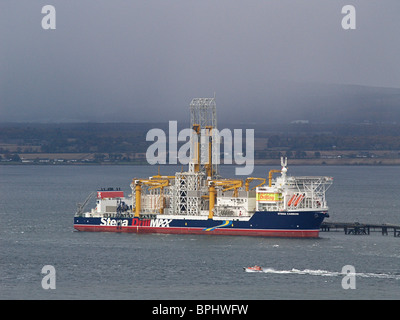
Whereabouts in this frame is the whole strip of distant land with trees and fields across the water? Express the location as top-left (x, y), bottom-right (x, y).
top-left (0, 123), bottom-right (400, 165)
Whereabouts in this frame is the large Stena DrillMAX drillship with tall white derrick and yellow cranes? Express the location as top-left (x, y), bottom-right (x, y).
top-left (74, 98), bottom-right (333, 238)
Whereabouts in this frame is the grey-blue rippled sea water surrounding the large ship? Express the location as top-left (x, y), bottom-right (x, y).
top-left (0, 166), bottom-right (400, 299)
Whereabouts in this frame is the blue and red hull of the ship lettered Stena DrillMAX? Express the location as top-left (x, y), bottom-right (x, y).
top-left (74, 211), bottom-right (328, 238)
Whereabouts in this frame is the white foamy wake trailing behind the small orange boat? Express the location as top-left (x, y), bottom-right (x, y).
top-left (245, 268), bottom-right (400, 280)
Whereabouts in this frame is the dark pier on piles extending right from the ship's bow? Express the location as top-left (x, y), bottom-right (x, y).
top-left (321, 222), bottom-right (400, 237)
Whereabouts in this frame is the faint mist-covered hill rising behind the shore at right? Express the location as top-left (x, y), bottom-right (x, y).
top-left (225, 83), bottom-right (400, 123)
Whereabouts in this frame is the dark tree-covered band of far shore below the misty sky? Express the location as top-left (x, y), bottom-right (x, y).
top-left (0, 123), bottom-right (400, 160)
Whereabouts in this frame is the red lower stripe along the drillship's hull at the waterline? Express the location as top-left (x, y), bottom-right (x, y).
top-left (74, 224), bottom-right (319, 238)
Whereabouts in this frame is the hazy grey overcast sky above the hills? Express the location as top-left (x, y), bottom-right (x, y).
top-left (0, 0), bottom-right (400, 122)
